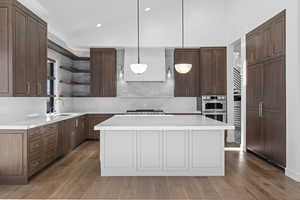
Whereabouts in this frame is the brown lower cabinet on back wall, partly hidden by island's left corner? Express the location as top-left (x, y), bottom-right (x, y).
top-left (87, 115), bottom-right (113, 140)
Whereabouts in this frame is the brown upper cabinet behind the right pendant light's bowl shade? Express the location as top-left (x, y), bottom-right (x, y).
top-left (174, 49), bottom-right (201, 97)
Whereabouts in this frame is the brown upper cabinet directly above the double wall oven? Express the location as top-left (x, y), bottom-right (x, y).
top-left (199, 47), bottom-right (227, 95)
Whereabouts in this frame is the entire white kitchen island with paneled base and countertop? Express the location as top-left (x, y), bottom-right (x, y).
top-left (94, 115), bottom-right (234, 176)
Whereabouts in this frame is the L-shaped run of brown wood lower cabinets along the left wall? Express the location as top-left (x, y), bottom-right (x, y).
top-left (0, 115), bottom-right (113, 185)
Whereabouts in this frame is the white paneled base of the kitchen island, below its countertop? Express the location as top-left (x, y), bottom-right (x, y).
top-left (100, 130), bottom-right (225, 176)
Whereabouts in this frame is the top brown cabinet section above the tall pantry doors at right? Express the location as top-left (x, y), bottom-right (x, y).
top-left (247, 12), bottom-right (286, 65)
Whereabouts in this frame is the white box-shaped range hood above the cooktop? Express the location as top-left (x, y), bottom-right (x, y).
top-left (124, 48), bottom-right (166, 82)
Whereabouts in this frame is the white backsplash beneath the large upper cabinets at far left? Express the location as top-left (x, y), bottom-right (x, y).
top-left (0, 97), bottom-right (47, 123)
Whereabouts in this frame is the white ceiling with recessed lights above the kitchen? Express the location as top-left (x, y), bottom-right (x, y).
top-left (19, 0), bottom-right (226, 50)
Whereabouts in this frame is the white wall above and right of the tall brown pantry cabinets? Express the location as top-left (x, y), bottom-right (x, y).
top-left (226, 0), bottom-right (300, 181)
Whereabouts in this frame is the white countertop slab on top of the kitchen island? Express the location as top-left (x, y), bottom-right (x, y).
top-left (94, 115), bottom-right (234, 131)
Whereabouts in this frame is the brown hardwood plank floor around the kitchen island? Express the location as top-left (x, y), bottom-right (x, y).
top-left (0, 142), bottom-right (300, 200)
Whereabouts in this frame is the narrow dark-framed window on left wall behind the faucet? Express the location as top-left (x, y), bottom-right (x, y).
top-left (47, 61), bottom-right (55, 113)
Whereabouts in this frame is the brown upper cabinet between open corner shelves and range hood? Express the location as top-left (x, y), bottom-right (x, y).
top-left (91, 49), bottom-right (117, 97)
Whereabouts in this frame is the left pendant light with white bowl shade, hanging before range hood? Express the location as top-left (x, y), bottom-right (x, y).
top-left (130, 0), bottom-right (148, 74)
